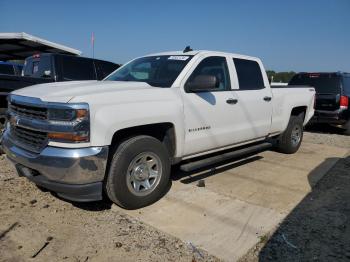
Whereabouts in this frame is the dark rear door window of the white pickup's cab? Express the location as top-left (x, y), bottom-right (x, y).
top-left (233, 58), bottom-right (265, 90)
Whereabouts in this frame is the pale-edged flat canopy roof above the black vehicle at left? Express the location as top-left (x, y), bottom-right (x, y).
top-left (0, 33), bottom-right (82, 61)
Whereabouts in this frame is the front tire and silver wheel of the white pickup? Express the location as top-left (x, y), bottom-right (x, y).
top-left (105, 135), bottom-right (171, 209)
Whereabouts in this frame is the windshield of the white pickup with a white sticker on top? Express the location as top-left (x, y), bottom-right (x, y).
top-left (105, 55), bottom-right (193, 87)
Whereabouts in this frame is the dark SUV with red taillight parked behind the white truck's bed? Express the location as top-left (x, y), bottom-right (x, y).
top-left (289, 72), bottom-right (350, 135)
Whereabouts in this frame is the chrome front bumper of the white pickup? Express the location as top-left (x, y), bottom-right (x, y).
top-left (2, 132), bottom-right (108, 202)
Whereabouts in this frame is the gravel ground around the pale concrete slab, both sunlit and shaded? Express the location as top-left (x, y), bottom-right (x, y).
top-left (0, 130), bottom-right (350, 262)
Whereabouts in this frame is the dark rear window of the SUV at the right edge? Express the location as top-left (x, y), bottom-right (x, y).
top-left (288, 74), bottom-right (341, 94)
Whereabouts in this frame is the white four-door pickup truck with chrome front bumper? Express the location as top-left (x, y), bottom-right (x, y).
top-left (2, 51), bottom-right (315, 209)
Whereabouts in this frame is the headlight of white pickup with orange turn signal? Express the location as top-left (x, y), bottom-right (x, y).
top-left (48, 104), bottom-right (90, 143)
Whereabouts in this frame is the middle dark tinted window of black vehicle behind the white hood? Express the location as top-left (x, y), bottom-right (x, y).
top-left (62, 56), bottom-right (96, 80)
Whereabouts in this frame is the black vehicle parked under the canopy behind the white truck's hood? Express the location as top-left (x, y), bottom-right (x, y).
top-left (0, 53), bottom-right (119, 134)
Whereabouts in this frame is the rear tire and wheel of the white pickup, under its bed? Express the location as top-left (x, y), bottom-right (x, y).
top-left (276, 115), bottom-right (304, 154)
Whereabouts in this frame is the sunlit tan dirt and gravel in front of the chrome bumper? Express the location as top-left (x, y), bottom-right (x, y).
top-left (0, 156), bottom-right (219, 261)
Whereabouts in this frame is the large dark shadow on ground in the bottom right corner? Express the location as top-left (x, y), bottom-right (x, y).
top-left (258, 156), bottom-right (350, 262)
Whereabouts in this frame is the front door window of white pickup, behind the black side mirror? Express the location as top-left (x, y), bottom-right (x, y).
top-left (187, 56), bottom-right (231, 91)
